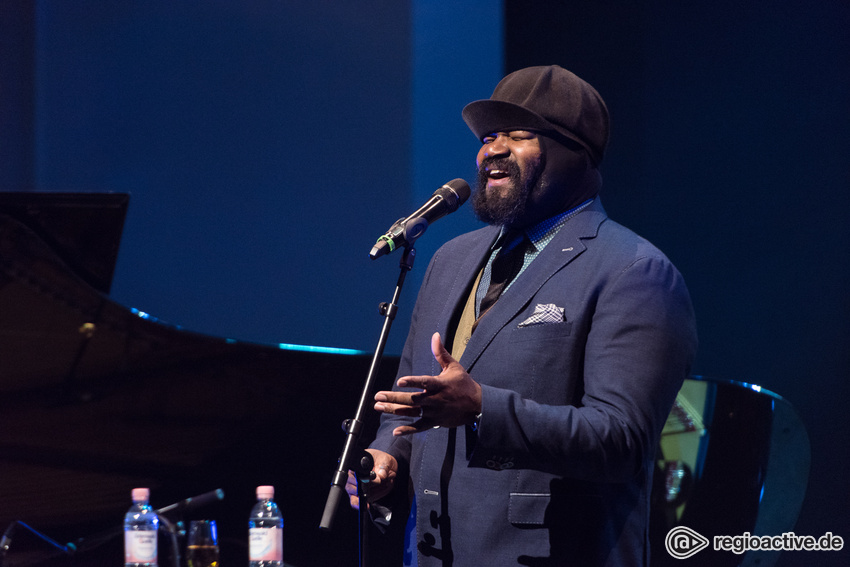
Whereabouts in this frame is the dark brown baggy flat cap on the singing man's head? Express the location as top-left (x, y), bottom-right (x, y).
top-left (463, 65), bottom-right (609, 165)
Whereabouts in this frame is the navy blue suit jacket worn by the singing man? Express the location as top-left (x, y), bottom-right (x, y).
top-left (372, 199), bottom-right (696, 567)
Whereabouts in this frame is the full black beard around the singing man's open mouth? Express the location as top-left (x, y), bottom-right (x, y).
top-left (472, 158), bottom-right (546, 228)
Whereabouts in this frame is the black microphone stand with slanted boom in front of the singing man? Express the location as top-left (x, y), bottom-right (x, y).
top-left (319, 242), bottom-right (416, 567)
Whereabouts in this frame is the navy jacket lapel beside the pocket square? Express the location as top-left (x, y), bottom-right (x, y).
top-left (460, 198), bottom-right (607, 371)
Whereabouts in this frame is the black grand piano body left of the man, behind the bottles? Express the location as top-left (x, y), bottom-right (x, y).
top-left (0, 193), bottom-right (398, 565)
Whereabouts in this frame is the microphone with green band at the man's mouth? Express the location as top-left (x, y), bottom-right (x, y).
top-left (369, 178), bottom-right (470, 260)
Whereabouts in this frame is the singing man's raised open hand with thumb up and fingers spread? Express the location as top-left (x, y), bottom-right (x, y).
top-left (375, 333), bottom-right (481, 436)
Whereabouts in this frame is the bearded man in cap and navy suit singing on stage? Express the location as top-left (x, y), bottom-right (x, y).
top-left (347, 66), bottom-right (697, 567)
